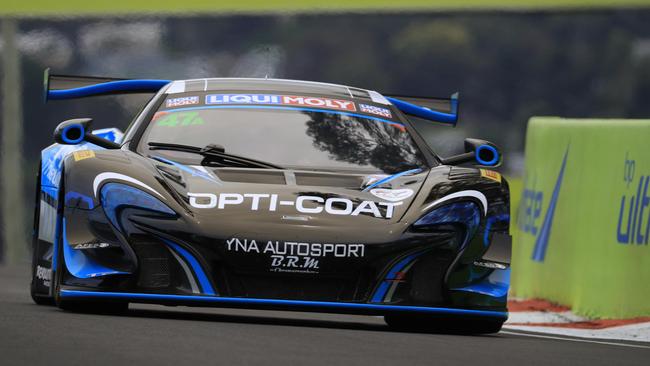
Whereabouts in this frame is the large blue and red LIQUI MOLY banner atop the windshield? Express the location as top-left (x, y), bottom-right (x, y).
top-left (205, 94), bottom-right (357, 112)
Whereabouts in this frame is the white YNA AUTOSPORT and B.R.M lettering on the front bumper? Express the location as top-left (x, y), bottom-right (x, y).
top-left (226, 238), bottom-right (366, 273)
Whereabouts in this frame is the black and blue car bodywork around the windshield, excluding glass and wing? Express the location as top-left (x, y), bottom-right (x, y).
top-left (32, 81), bottom-right (510, 320)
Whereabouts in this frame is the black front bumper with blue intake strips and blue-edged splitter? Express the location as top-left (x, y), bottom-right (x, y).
top-left (61, 194), bottom-right (509, 317)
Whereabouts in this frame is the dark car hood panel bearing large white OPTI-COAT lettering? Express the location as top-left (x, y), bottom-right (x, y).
top-left (155, 161), bottom-right (428, 232)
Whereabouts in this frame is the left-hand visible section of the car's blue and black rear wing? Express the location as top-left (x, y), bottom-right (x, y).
top-left (43, 69), bottom-right (170, 101)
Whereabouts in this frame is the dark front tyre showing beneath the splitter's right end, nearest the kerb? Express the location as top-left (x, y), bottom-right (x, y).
top-left (384, 314), bottom-right (504, 334)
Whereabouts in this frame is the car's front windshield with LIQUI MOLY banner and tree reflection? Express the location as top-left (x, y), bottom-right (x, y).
top-left (139, 93), bottom-right (426, 174)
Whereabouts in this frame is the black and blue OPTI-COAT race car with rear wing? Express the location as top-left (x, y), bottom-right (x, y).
top-left (31, 71), bottom-right (511, 333)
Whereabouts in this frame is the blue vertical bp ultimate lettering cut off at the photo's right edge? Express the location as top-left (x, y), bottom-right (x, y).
top-left (616, 153), bottom-right (650, 245)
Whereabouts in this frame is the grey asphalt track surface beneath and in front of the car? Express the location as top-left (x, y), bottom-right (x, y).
top-left (0, 267), bottom-right (650, 366)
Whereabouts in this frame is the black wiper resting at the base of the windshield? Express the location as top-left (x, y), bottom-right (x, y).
top-left (148, 142), bottom-right (284, 169)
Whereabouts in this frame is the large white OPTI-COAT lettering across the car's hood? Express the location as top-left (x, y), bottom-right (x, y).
top-left (187, 193), bottom-right (400, 219)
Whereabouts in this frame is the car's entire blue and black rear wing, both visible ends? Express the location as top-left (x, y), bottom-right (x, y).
top-left (43, 69), bottom-right (458, 125)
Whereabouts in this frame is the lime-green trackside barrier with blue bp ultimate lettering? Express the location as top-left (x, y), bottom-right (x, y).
top-left (512, 117), bottom-right (650, 318)
